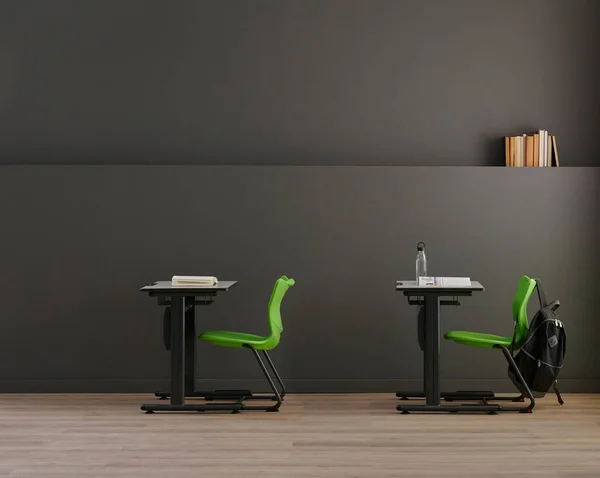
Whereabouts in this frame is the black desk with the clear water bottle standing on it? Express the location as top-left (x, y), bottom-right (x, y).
top-left (396, 280), bottom-right (500, 413)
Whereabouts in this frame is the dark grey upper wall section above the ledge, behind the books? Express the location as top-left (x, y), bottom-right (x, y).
top-left (0, 0), bottom-right (600, 166)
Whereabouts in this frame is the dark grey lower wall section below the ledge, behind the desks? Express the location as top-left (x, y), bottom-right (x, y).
top-left (0, 166), bottom-right (600, 392)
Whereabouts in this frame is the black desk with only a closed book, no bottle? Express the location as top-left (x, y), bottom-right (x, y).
top-left (141, 281), bottom-right (237, 413)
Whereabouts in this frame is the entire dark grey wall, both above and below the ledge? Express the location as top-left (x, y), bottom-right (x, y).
top-left (0, 0), bottom-right (600, 392)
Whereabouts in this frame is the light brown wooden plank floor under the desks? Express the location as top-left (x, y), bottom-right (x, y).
top-left (0, 395), bottom-right (600, 478)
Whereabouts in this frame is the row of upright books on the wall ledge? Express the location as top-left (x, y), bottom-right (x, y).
top-left (504, 129), bottom-right (560, 168)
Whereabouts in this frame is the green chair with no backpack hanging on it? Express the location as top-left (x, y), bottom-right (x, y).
top-left (198, 276), bottom-right (295, 412)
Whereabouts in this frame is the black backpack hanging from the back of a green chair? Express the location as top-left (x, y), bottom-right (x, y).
top-left (508, 279), bottom-right (567, 400)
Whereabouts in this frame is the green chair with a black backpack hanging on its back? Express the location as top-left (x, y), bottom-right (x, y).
top-left (444, 276), bottom-right (540, 413)
